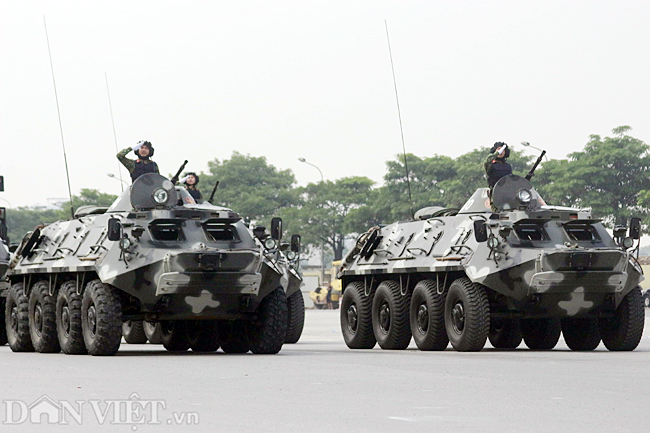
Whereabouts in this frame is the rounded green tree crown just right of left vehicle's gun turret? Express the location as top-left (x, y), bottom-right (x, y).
top-left (199, 152), bottom-right (298, 221)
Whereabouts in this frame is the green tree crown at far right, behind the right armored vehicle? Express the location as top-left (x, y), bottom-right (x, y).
top-left (539, 126), bottom-right (650, 225)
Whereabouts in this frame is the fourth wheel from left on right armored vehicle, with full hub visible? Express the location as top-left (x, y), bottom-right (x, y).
top-left (445, 278), bottom-right (490, 352)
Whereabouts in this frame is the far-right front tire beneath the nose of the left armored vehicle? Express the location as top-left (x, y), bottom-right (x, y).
top-left (246, 287), bottom-right (287, 354)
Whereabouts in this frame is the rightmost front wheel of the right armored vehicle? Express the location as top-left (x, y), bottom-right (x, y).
top-left (599, 287), bottom-right (645, 351)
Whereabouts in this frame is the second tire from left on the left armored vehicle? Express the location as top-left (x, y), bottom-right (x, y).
top-left (29, 281), bottom-right (61, 353)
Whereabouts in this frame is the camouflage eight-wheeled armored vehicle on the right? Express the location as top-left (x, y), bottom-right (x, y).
top-left (338, 175), bottom-right (644, 351)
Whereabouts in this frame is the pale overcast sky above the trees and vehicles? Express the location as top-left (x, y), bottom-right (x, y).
top-left (0, 0), bottom-right (650, 207)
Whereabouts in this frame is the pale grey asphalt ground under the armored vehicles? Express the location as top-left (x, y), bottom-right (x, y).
top-left (0, 310), bottom-right (650, 433)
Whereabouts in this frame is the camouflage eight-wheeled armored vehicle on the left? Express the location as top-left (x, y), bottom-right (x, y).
top-left (3, 173), bottom-right (304, 355)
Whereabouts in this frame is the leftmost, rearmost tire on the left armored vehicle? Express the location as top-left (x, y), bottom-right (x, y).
top-left (5, 283), bottom-right (34, 352)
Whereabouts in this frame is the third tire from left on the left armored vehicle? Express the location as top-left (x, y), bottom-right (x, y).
top-left (56, 281), bottom-right (88, 355)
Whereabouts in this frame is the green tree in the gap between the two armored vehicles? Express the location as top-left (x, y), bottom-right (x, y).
top-left (282, 176), bottom-right (374, 260)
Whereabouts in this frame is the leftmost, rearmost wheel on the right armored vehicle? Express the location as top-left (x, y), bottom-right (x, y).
top-left (341, 281), bottom-right (377, 349)
